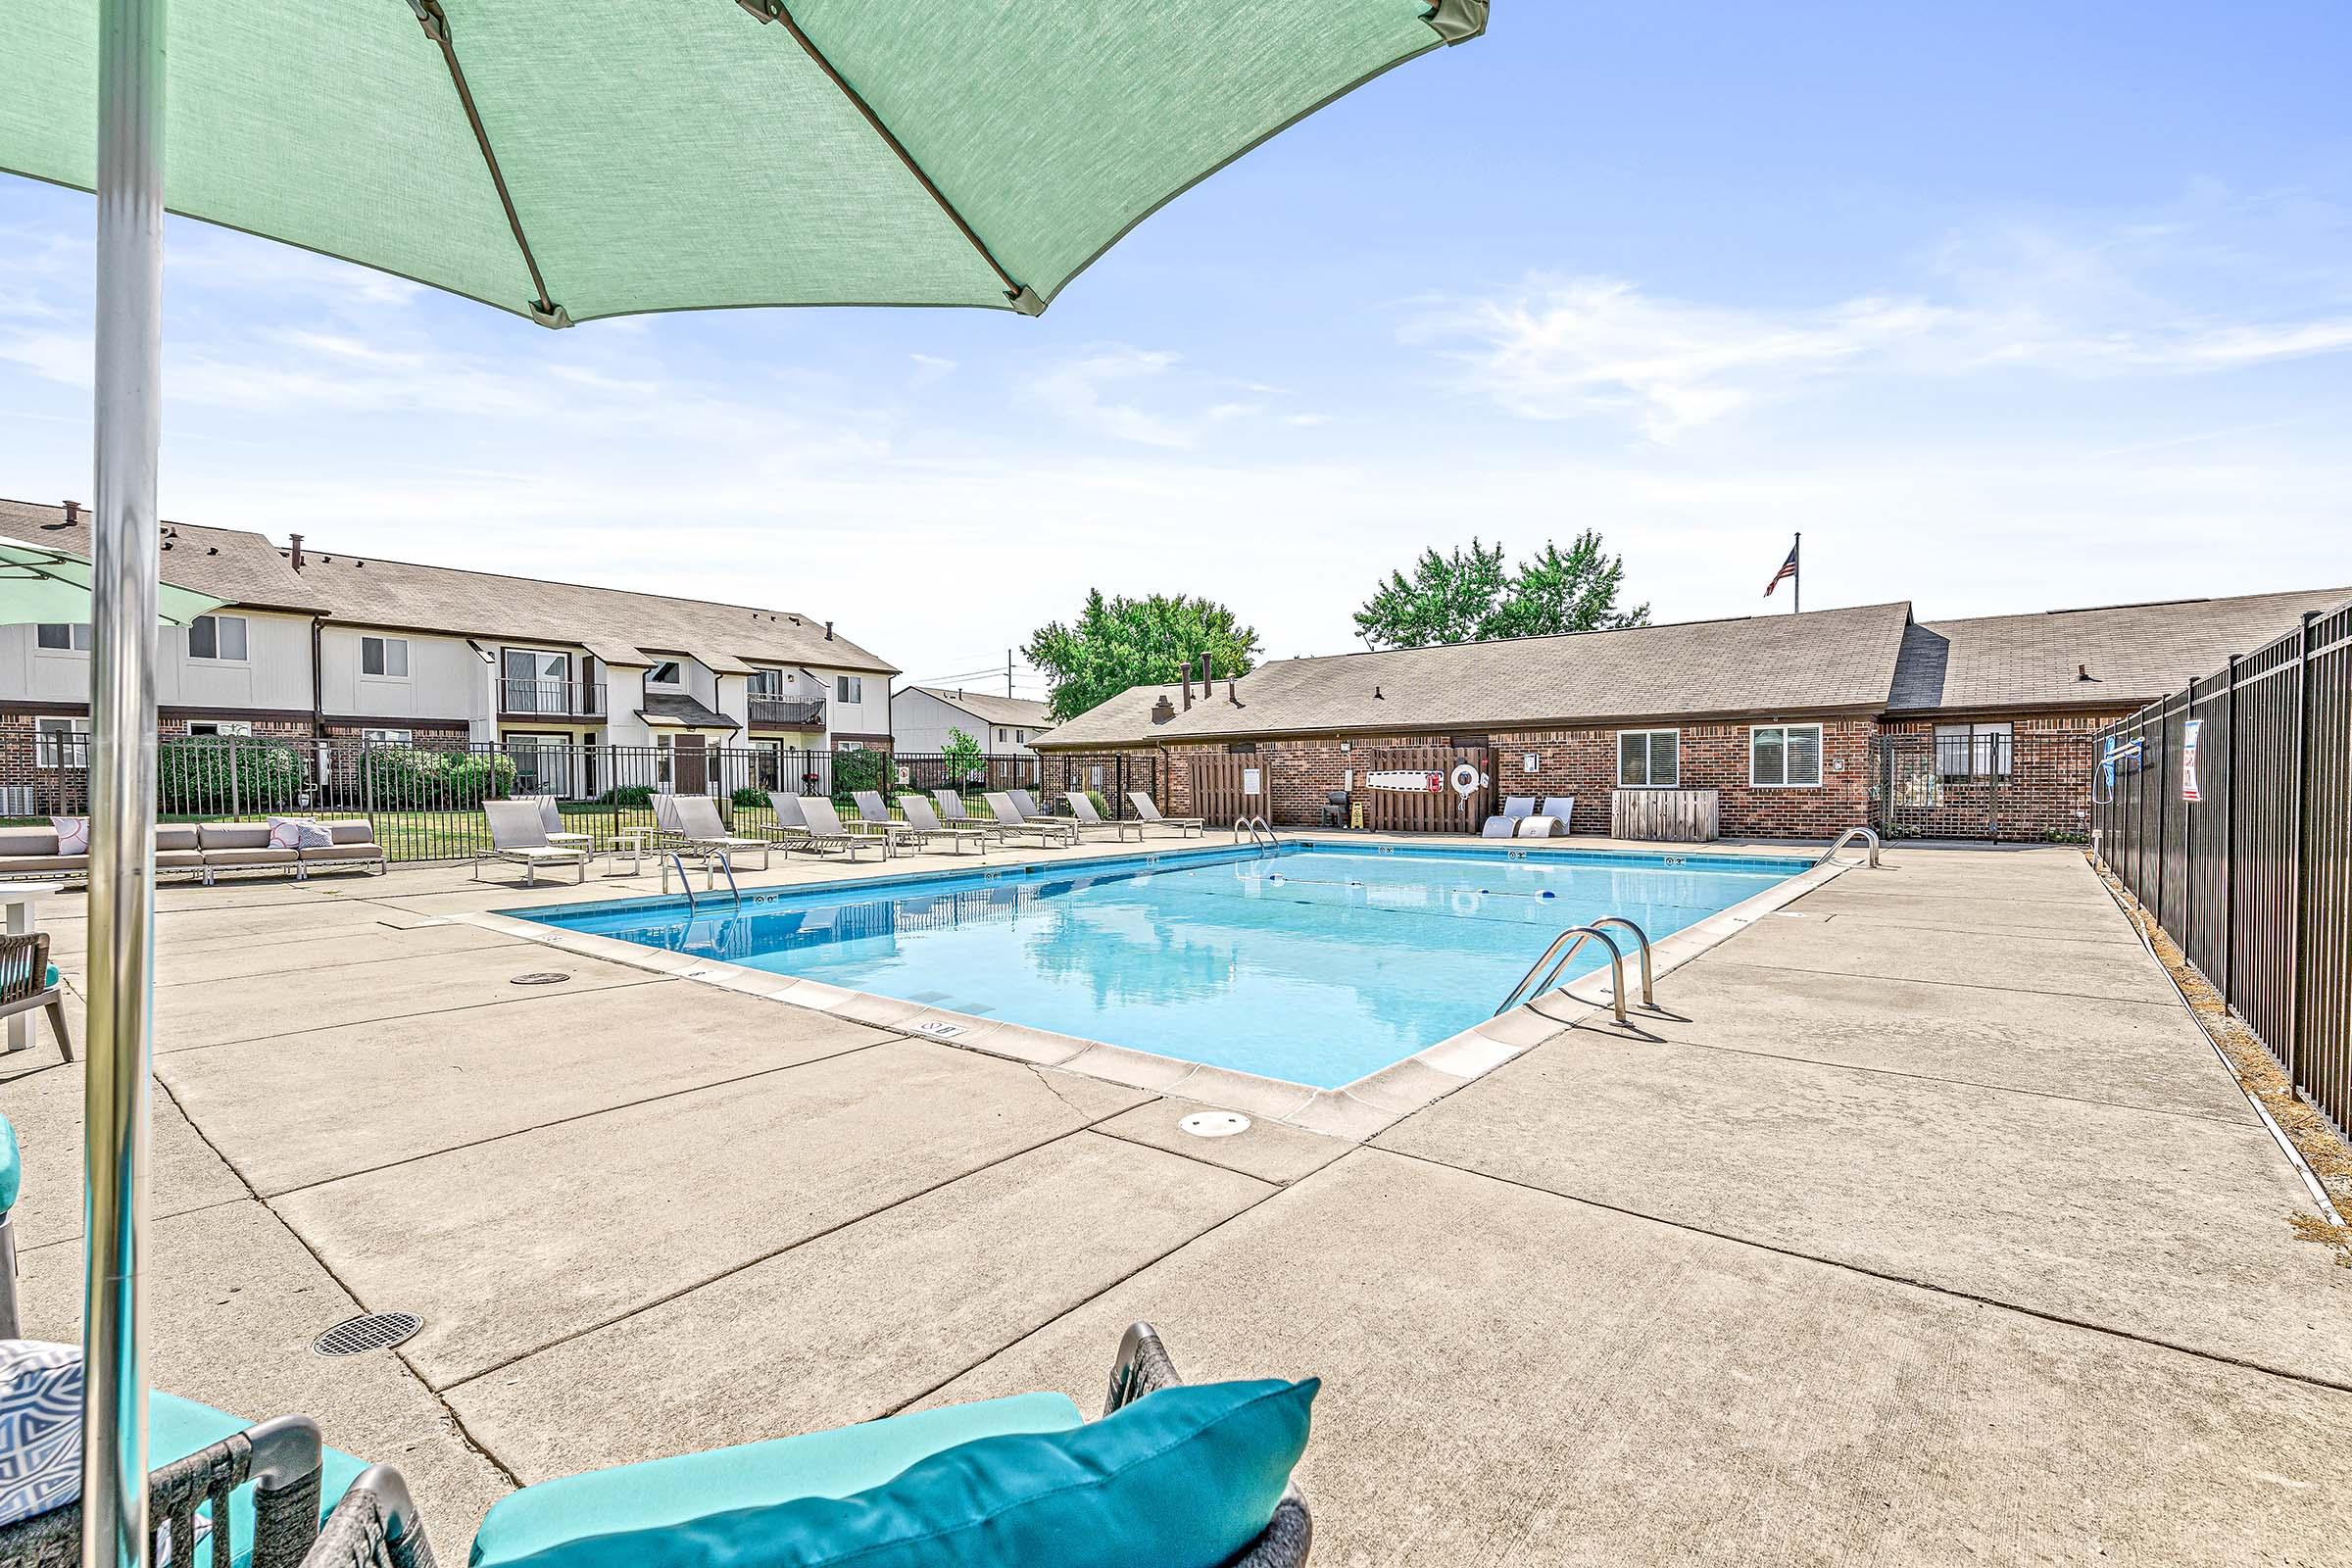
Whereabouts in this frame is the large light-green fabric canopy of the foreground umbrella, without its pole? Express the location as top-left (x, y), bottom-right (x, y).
top-left (0, 0), bottom-right (1487, 324)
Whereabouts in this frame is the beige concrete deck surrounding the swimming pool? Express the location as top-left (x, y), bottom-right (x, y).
top-left (0, 839), bottom-right (2352, 1563)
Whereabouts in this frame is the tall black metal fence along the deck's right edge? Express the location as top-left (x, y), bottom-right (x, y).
top-left (2091, 604), bottom-right (2352, 1131)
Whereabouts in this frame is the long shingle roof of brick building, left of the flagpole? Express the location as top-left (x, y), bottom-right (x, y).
top-left (1037, 604), bottom-right (1910, 748)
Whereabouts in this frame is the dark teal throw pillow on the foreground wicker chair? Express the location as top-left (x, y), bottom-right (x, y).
top-left (498, 1380), bottom-right (1317, 1568)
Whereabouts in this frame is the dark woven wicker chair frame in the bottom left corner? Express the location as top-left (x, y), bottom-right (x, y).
top-left (0, 1415), bottom-right (326, 1568)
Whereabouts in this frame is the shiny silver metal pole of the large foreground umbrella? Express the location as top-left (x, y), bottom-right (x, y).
top-left (82, 0), bottom-right (163, 1568)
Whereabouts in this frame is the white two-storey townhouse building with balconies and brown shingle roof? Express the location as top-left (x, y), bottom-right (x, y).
top-left (0, 501), bottom-right (896, 795)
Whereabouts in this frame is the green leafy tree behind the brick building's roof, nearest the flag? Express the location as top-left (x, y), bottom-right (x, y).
top-left (1354, 529), bottom-right (1648, 649)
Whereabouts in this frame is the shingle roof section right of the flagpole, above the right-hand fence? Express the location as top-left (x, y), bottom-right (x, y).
top-left (1886, 588), bottom-right (2352, 712)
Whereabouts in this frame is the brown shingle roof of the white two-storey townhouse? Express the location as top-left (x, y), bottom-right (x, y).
top-left (0, 501), bottom-right (899, 674)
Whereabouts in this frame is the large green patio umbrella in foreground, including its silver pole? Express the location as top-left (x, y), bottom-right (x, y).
top-left (0, 0), bottom-right (1487, 1568)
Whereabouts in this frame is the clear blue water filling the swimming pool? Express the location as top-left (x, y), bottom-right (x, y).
top-left (511, 844), bottom-right (1806, 1089)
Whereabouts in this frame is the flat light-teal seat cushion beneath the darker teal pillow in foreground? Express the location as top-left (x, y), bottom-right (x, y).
top-left (470, 1394), bottom-right (1087, 1568)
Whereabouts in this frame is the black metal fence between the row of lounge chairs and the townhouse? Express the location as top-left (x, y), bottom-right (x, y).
top-left (0, 726), bottom-right (1058, 860)
